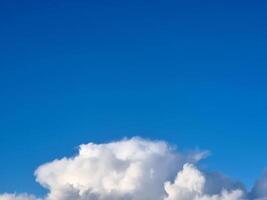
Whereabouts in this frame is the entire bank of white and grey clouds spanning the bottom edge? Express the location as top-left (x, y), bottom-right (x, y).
top-left (0, 138), bottom-right (267, 200)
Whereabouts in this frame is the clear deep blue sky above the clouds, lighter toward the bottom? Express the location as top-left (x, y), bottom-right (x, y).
top-left (0, 0), bottom-right (267, 197)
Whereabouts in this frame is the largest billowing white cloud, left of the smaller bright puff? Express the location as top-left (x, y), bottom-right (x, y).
top-left (35, 138), bottom-right (204, 200)
